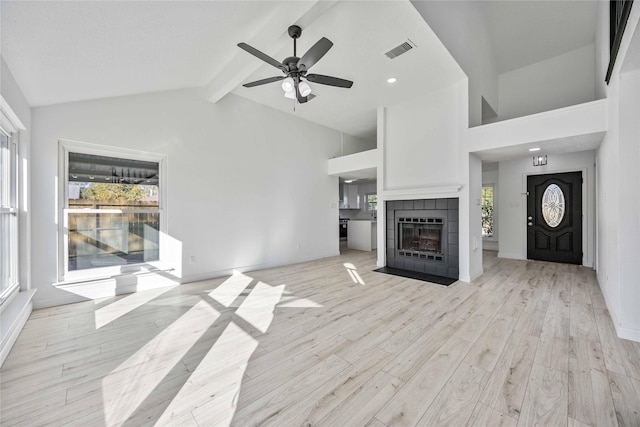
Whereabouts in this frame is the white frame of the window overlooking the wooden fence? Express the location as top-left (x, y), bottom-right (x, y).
top-left (56, 140), bottom-right (167, 284)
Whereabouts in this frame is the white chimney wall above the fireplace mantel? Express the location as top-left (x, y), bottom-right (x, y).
top-left (383, 85), bottom-right (460, 190)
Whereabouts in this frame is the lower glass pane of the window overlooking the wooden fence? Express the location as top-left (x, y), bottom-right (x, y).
top-left (68, 212), bottom-right (160, 271)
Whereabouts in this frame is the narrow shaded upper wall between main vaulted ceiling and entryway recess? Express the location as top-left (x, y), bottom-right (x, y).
top-left (411, 1), bottom-right (500, 127)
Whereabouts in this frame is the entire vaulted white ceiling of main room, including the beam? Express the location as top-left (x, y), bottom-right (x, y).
top-left (1, 0), bottom-right (463, 139)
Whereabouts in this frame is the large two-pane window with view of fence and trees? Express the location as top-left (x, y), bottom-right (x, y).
top-left (62, 147), bottom-right (162, 280)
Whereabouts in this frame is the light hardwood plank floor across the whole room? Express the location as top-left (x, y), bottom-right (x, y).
top-left (0, 251), bottom-right (640, 427)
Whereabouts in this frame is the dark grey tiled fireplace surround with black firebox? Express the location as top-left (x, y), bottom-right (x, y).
top-left (386, 198), bottom-right (459, 279)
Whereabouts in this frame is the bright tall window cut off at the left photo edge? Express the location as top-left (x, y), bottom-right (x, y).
top-left (0, 128), bottom-right (18, 302)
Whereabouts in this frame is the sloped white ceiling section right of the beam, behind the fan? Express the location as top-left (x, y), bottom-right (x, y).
top-left (233, 1), bottom-right (464, 139)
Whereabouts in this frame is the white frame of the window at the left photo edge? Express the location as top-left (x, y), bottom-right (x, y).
top-left (0, 127), bottom-right (20, 306)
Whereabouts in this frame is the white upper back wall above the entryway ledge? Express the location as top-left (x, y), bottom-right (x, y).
top-left (498, 44), bottom-right (596, 120)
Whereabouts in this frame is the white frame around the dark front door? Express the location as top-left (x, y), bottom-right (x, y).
top-left (520, 167), bottom-right (595, 267)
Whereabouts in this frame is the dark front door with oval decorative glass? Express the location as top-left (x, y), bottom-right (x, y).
top-left (527, 172), bottom-right (582, 264)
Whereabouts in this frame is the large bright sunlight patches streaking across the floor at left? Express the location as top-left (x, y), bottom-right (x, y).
top-left (100, 273), bottom-right (321, 425)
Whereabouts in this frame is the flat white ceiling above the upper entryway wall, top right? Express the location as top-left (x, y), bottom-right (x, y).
top-left (480, 0), bottom-right (598, 74)
